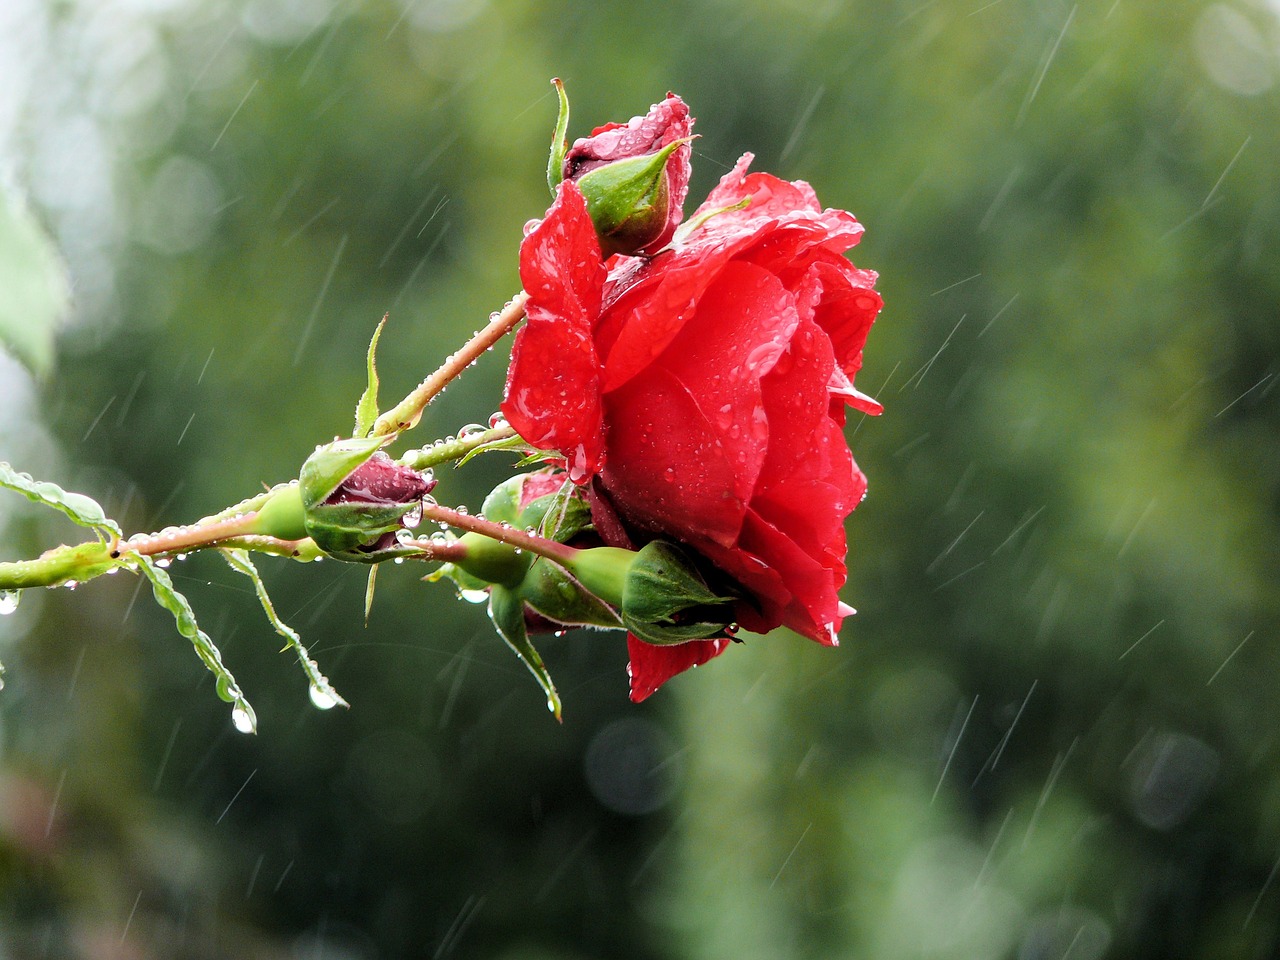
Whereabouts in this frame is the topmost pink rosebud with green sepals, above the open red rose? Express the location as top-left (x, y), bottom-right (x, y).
top-left (549, 83), bottom-right (692, 257)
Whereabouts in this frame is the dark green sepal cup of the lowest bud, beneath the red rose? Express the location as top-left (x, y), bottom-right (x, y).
top-left (622, 540), bottom-right (733, 645)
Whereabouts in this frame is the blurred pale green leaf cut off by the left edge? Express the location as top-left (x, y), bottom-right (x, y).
top-left (0, 186), bottom-right (70, 376)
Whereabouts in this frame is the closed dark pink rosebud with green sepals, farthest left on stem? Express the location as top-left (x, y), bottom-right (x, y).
top-left (257, 436), bottom-right (435, 563)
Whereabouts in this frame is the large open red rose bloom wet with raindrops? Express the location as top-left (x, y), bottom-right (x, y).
top-left (503, 155), bottom-right (881, 700)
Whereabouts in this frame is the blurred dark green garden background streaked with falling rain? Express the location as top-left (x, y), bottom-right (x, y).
top-left (0, 0), bottom-right (1280, 960)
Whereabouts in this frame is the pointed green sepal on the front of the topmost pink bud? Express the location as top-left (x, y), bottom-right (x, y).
top-left (575, 137), bottom-right (692, 256)
